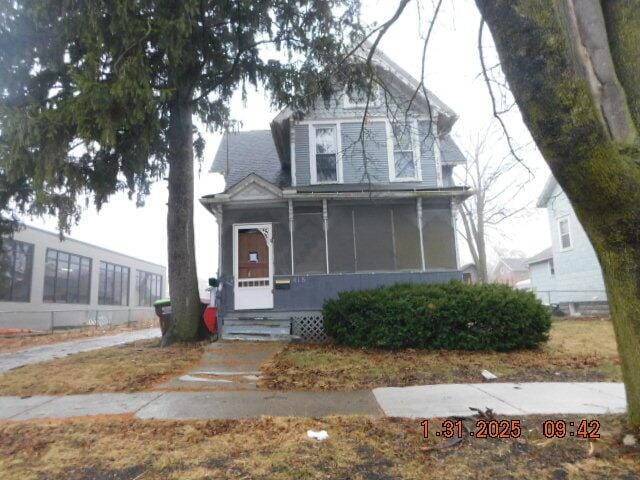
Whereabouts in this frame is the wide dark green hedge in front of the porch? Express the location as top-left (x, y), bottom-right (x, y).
top-left (323, 282), bottom-right (551, 351)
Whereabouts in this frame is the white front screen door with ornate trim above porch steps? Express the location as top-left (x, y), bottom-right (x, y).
top-left (233, 223), bottom-right (273, 310)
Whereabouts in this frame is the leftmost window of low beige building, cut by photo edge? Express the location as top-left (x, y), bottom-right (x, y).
top-left (0, 239), bottom-right (34, 302)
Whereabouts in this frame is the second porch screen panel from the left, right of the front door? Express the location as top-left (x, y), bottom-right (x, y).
top-left (328, 204), bottom-right (356, 273)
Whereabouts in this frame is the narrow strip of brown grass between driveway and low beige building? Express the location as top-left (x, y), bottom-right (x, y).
top-left (0, 320), bottom-right (158, 353)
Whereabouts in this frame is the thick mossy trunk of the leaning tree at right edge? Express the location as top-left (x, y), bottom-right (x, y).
top-left (476, 0), bottom-right (640, 428)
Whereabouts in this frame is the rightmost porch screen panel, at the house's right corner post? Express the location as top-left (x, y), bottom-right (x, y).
top-left (422, 207), bottom-right (457, 269)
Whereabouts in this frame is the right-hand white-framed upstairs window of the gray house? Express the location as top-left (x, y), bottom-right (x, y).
top-left (387, 121), bottom-right (422, 182)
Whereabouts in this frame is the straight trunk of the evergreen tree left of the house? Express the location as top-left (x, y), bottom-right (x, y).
top-left (163, 92), bottom-right (200, 345)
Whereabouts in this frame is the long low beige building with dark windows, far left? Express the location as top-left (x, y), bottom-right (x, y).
top-left (0, 227), bottom-right (167, 330)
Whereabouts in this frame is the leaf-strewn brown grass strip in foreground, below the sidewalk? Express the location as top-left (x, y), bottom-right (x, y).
top-left (0, 416), bottom-right (640, 480)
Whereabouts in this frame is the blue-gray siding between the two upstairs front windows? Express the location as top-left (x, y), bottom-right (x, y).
top-left (340, 122), bottom-right (389, 183)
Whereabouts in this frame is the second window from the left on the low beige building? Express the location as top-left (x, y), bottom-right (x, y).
top-left (44, 248), bottom-right (91, 304)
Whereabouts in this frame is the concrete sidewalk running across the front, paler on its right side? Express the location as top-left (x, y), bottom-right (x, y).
top-left (0, 383), bottom-right (626, 420)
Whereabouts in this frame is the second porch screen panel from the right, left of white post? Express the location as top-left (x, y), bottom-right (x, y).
top-left (392, 202), bottom-right (422, 270)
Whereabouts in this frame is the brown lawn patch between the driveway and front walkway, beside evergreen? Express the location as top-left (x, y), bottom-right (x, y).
top-left (0, 339), bottom-right (203, 396)
